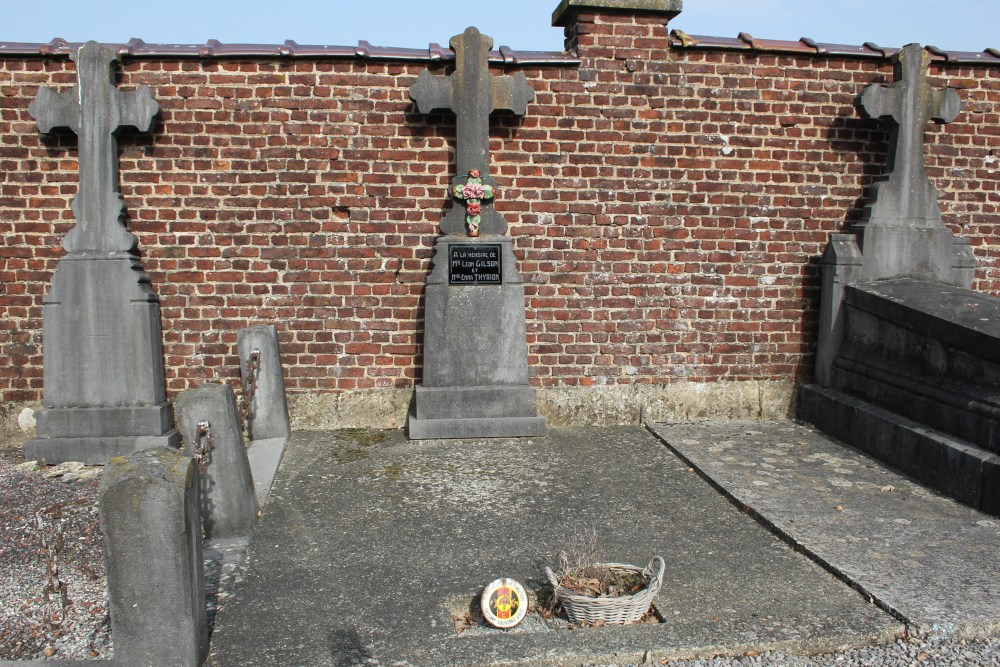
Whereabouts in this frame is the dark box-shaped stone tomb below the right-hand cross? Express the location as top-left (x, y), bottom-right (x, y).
top-left (798, 279), bottom-right (1000, 513)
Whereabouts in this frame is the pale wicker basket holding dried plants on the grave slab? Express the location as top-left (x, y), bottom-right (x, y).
top-left (545, 556), bottom-right (666, 625)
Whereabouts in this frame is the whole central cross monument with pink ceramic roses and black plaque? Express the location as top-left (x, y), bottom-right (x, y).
top-left (409, 28), bottom-right (545, 439)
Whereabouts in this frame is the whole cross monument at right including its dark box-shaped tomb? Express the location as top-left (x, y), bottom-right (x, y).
top-left (798, 44), bottom-right (1000, 514)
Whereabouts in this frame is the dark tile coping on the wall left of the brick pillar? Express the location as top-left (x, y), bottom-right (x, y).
top-left (0, 37), bottom-right (580, 66)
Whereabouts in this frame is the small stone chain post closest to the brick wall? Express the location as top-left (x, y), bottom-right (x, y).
top-left (236, 324), bottom-right (292, 440)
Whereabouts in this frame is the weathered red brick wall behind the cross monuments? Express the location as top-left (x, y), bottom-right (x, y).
top-left (0, 7), bottom-right (1000, 426)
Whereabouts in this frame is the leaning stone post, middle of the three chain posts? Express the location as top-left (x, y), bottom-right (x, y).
top-left (176, 384), bottom-right (258, 538)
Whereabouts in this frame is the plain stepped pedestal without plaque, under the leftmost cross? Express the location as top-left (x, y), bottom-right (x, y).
top-left (25, 253), bottom-right (180, 464)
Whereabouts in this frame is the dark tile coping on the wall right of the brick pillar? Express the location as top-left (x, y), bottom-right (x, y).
top-left (670, 29), bottom-right (1000, 66)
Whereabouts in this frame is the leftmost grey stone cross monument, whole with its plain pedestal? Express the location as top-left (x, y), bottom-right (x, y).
top-left (25, 42), bottom-right (180, 463)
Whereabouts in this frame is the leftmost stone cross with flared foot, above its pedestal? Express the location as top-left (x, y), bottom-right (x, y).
top-left (28, 42), bottom-right (160, 253)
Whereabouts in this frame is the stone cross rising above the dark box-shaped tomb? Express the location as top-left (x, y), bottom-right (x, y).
top-left (861, 44), bottom-right (962, 221)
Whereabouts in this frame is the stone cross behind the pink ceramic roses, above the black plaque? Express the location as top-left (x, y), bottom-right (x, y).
top-left (410, 27), bottom-right (535, 234)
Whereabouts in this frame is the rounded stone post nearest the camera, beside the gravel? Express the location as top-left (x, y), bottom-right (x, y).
top-left (98, 448), bottom-right (208, 667)
